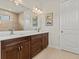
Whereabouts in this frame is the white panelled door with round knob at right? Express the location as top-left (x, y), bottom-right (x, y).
top-left (60, 0), bottom-right (79, 54)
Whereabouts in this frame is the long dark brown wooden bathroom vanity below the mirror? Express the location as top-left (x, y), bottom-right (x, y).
top-left (0, 32), bottom-right (48, 59)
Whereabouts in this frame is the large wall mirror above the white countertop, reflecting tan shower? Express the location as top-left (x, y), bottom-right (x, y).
top-left (0, 0), bottom-right (38, 31)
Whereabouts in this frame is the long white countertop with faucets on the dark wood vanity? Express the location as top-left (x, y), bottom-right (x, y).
top-left (0, 31), bottom-right (48, 41)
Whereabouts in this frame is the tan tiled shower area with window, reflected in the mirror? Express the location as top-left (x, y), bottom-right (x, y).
top-left (0, 9), bottom-right (22, 31)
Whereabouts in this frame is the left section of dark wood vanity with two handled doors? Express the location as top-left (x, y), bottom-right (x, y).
top-left (1, 37), bottom-right (30, 59)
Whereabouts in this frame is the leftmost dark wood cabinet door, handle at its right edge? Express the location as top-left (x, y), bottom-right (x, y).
top-left (1, 45), bottom-right (19, 59)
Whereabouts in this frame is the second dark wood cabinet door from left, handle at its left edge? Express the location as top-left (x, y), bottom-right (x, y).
top-left (20, 41), bottom-right (31, 59)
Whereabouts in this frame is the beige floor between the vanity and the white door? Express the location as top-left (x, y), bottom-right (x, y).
top-left (33, 48), bottom-right (79, 59)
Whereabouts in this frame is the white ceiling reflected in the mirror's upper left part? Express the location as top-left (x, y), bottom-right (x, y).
top-left (0, 0), bottom-right (23, 13)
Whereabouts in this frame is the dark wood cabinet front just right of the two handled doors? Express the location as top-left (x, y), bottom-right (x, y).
top-left (31, 35), bottom-right (42, 57)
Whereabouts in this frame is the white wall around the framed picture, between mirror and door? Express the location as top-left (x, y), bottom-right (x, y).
top-left (39, 0), bottom-right (60, 48)
